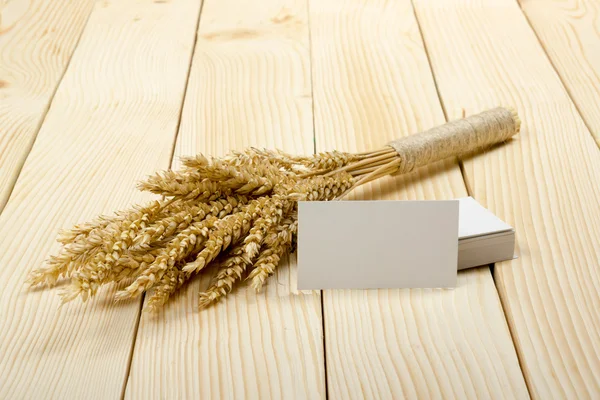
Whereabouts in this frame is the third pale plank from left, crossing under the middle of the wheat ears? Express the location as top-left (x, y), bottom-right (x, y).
top-left (126, 0), bottom-right (325, 399)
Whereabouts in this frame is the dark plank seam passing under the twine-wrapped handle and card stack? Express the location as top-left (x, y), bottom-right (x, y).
top-left (411, 0), bottom-right (539, 398)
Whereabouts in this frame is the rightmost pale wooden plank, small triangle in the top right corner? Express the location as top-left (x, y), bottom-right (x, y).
top-left (520, 0), bottom-right (600, 146)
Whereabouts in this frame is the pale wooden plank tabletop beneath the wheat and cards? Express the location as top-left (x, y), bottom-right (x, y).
top-left (0, 0), bottom-right (600, 399)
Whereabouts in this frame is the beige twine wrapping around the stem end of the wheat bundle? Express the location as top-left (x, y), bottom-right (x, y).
top-left (388, 107), bottom-right (521, 174)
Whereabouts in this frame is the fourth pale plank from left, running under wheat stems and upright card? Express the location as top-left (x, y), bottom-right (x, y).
top-left (309, 0), bottom-right (528, 399)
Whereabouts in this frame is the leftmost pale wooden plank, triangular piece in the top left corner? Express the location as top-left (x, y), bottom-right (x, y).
top-left (0, 0), bottom-right (94, 212)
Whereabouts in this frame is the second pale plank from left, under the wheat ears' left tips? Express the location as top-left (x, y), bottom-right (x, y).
top-left (0, 0), bottom-right (199, 399)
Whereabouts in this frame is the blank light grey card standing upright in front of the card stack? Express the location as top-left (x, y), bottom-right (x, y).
top-left (298, 200), bottom-right (459, 290)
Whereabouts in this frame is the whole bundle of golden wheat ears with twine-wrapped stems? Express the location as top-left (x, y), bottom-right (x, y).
top-left (28, 108), bottom-right (519, 310)
